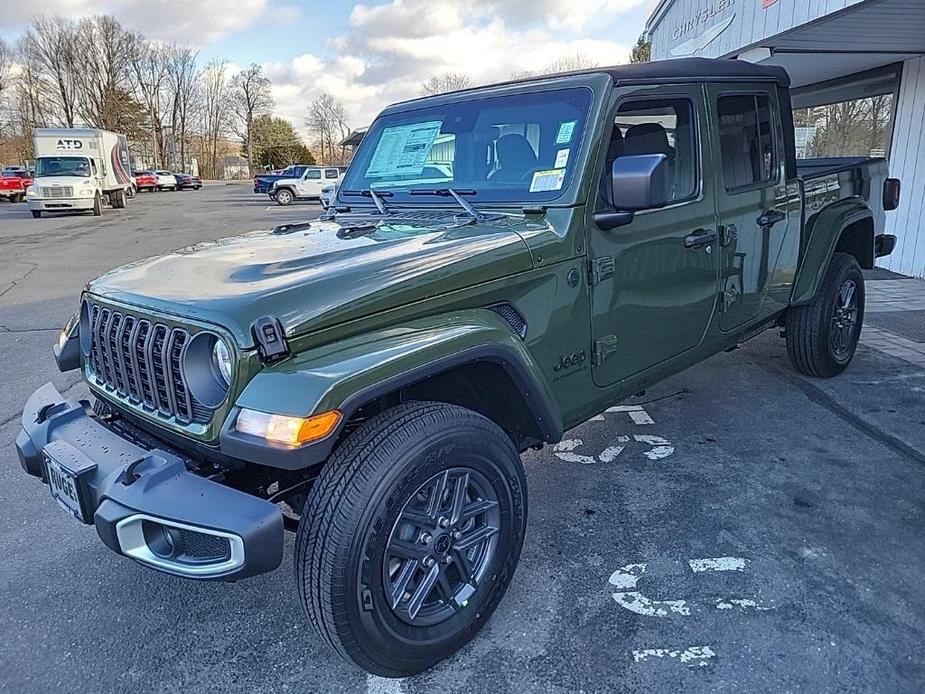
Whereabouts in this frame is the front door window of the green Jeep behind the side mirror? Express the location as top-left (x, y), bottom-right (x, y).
top-left (605, 97), bottom-right (699, 202)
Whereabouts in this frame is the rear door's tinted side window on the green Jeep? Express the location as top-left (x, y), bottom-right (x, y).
top-left (717, 94), bottom-right (777, 190)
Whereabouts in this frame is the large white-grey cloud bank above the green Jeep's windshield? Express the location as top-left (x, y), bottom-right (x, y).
top-left (264, 0), bottom-right (654, 137)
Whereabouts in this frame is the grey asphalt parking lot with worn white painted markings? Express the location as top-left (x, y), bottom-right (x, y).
top-left (0, 184), bottom-right (925, 694)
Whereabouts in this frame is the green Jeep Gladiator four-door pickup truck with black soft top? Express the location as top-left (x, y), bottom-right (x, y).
top-left (17, 59), bottom-right (899, 677)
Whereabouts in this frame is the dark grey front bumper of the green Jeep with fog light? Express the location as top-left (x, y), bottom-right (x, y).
top-left (16, 383), bottom-right (283, 581)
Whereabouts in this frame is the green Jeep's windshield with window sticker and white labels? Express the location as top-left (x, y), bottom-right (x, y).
top-left (339, 88), bottom-right (591, 204)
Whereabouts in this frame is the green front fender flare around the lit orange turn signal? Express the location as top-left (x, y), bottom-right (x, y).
top-left (220, 309), bottom-right (563, 469)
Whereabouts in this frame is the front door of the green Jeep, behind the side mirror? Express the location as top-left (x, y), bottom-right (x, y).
top-left (588, 84), bottom-right (719, 386)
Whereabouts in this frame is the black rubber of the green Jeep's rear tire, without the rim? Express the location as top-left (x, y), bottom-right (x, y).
top-left (787, 253), bottom-right (863, 378)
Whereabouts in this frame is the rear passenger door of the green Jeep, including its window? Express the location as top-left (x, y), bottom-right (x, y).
top-left (708, 83), bottom-right (799, 332)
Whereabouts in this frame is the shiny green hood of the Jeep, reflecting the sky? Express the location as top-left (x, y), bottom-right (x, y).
top-left (88, 212), bottom-right (533, 348)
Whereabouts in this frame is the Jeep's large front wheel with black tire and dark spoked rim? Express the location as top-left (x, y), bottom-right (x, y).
top-left (295, 402), bottom-right (527, 677)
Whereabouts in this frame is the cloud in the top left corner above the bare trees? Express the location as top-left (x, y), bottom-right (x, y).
top-left (0, 0), bottom-right (301, 48)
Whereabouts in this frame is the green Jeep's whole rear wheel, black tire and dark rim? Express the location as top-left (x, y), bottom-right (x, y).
top-left (786, 253), bottom-right (864, 378)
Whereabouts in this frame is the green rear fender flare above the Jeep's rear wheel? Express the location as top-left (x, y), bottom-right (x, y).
top-left (790, 198), bottom-right (873, 306)
